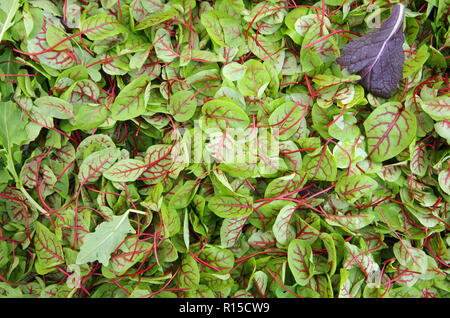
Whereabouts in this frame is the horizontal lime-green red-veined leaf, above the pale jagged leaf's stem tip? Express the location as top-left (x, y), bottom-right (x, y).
top-left (103, 159), bottom-right (147, 182)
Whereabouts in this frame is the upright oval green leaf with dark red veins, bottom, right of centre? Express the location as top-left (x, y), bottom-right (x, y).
top-left (287, 239), bottom-right (314, 286)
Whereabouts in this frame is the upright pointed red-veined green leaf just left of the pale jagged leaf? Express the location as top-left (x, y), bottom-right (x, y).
top-left (34, 222), bottom-right (64, 274)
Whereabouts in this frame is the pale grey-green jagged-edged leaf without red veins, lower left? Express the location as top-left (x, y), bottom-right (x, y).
top-left (77, 212), bottom-right (135, 266)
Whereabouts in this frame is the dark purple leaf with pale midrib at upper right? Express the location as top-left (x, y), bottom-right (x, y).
top-left (337, 5), bottom-right (405, 98)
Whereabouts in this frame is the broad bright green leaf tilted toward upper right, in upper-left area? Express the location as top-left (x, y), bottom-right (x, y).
top-left (110, 76), bottom-right (150, 120)
